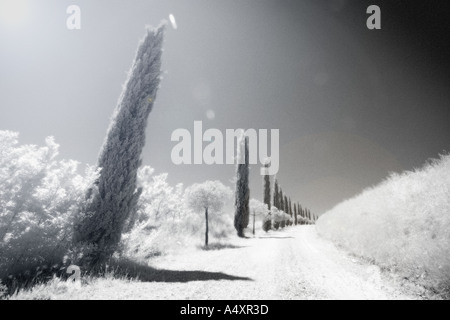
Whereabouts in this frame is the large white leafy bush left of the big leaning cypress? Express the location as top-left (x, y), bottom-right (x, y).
top-left (0, 131), bottom-right (95, 283)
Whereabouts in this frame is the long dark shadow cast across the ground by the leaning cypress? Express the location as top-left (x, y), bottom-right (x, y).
top-left (114, 260), bottom-right (253, 282)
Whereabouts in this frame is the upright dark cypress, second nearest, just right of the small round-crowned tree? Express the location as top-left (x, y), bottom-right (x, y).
top-left (234, 136), bottom-right (250, 238)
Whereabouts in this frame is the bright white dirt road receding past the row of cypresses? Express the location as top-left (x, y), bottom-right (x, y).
top-left (29, 226), bottom-right (414, 300)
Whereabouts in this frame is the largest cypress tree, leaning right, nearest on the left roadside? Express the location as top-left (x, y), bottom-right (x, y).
top-left (74, 25), bottom-right (164, 267)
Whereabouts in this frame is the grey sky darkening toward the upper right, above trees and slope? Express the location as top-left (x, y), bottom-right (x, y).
top-left (0, 0), bottom-right (450, 214)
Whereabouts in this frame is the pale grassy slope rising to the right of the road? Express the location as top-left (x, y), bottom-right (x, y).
top-left (317, 155), bottom-right (450, 292)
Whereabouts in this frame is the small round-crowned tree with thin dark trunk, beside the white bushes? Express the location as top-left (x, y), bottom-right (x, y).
top-left (185, 181), bottom-right (232, 246)
